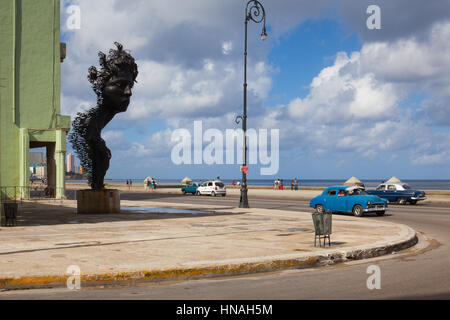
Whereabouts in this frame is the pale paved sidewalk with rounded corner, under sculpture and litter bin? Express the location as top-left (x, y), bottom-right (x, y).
top-left (0, 200), bottom-right (417, 289)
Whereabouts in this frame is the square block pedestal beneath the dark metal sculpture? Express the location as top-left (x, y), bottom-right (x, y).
top-left (77, 189), bottom-right (120, 214)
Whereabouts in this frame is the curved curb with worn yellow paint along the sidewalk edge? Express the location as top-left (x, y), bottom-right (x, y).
top-left (0, 226), bottom-right (418, 290)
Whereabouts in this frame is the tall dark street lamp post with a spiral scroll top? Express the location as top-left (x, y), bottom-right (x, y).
top-left (236, 0), bottom-right (267, 208)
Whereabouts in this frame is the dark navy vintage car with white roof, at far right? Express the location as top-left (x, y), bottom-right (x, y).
top-left (366, 183), bottom-right (427, 204)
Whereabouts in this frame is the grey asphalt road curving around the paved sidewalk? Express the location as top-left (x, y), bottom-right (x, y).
top-left (0, 193), bottom-right (450, 300)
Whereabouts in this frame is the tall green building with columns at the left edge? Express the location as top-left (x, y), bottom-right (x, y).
top-left (0, 0), bottom-right (70, 198)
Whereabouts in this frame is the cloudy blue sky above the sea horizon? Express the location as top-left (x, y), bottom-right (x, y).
top-left (61, 0), bottom-right (450, 179)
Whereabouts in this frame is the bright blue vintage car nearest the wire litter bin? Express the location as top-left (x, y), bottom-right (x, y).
top-left (309, 186), bottom-right (387, 217)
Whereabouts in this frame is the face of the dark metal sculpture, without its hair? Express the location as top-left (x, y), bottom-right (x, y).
top-left (103, 69), bottom-right (134, 113)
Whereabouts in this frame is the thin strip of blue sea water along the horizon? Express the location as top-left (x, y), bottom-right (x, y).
top-left (66, 178), bottom-right (450, 190)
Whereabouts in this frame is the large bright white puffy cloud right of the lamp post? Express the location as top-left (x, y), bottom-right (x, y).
top-left (288, 52), bottom-right (400, 124)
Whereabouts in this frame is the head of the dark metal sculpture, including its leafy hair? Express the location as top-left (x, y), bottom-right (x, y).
top-left (88, 42), bottom-right (138, 113)
